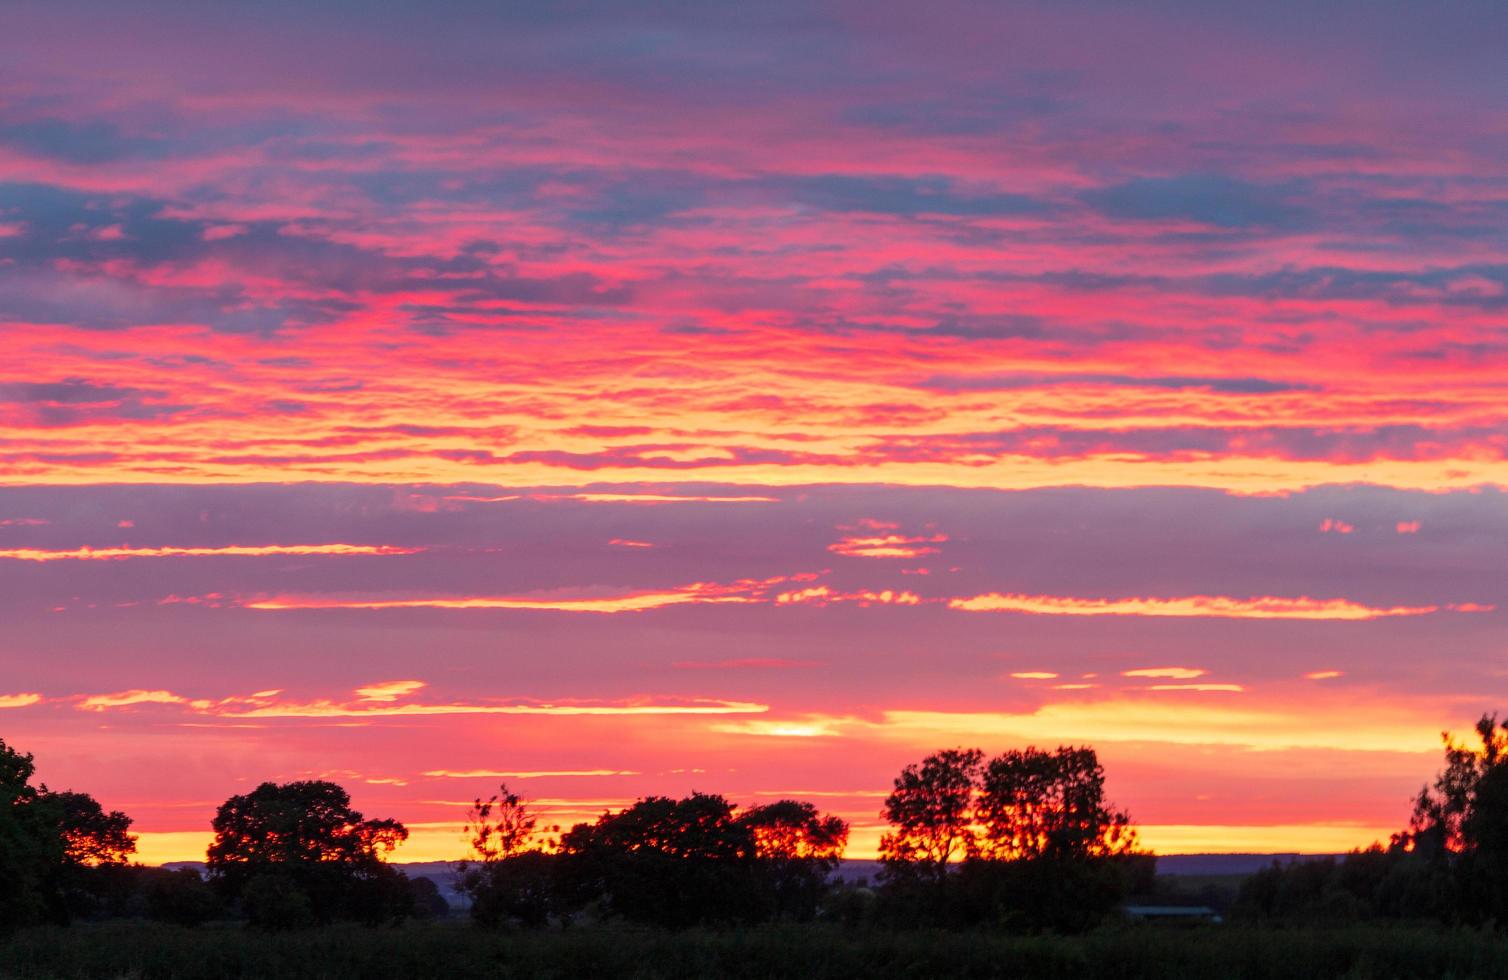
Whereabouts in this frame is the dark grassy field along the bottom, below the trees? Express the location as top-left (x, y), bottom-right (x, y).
top-left (0, 921), bottom-right (1508, 980)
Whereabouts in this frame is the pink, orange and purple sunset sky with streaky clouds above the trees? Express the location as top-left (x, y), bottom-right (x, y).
top-left (0, 0), bottom-right (1508, 862)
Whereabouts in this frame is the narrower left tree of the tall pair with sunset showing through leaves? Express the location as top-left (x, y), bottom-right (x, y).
top-left (879, 749), bottom-right (985, 879)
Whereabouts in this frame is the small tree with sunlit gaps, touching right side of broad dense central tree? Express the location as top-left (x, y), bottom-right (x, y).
top-left (737, 799), bottom-right (849, 921)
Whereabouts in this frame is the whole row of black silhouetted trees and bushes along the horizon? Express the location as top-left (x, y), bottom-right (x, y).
top-left (0, 708), bottom-right (1508, 932)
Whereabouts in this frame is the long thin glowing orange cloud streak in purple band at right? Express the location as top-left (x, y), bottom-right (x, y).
top-left (949, 593), bottom-right (1491, 620)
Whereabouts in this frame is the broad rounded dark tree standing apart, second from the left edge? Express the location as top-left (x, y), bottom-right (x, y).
top-left (207, 779), bottom-right (409, 921)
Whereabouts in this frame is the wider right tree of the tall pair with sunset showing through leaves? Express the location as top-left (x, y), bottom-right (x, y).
top-left (976, 746), bottom-right (1136, 861)
